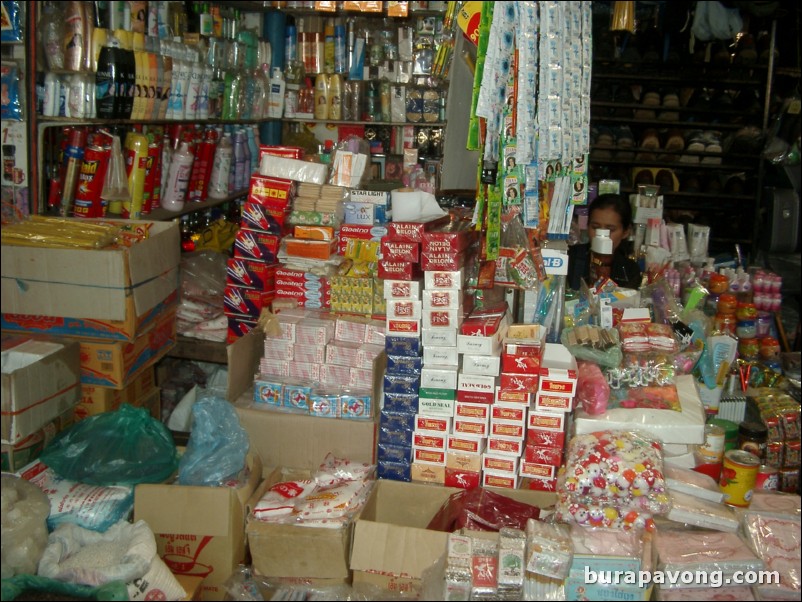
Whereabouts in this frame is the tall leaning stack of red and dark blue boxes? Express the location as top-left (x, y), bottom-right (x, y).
top-left (223, 174), bottom-right (296, 343)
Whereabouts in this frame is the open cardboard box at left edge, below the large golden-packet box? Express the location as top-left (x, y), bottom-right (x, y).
top-left (0, 337), bottom-right (81, 445)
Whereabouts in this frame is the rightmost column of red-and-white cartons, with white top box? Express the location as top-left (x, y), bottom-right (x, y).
top-left (520, 343), bottom-right (577, 491)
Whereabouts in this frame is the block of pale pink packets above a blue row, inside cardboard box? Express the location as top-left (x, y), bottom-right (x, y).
top-left (253, 309), bottom-right (384, 420)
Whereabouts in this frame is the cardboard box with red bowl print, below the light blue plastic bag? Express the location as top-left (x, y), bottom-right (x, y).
top-left (134, 454), bottom-right (262, 600)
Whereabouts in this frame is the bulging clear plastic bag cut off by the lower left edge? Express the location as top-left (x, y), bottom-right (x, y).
top-left (2, 474), bottom-right (50, 576)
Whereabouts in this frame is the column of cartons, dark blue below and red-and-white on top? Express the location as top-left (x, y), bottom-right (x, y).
top-left (377, 280), bottom-right (422, 481)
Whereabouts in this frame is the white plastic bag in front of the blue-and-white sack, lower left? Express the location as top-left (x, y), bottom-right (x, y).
top-left (39, 520), bottom-right (156, 585)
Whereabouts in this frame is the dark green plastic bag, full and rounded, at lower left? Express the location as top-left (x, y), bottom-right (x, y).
top-left (41, 404), bottom-right (178, 485)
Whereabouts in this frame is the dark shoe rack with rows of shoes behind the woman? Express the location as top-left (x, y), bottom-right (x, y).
top-left (590, 21), bottom-right (776, 254)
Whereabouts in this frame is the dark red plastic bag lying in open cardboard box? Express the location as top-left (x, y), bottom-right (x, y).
top-left (426, 487), bottom-right (540, 533)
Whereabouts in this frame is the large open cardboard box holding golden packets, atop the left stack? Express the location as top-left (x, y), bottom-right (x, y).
top-left (0, 220), bottom-right (181, 341)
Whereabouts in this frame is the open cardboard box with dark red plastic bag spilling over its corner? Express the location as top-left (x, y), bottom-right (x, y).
top-left (351, 481), bottom-right (556, 591)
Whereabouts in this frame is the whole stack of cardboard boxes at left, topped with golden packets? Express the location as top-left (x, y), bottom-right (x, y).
top-left (2, 217), bottom-right (180, 422)
